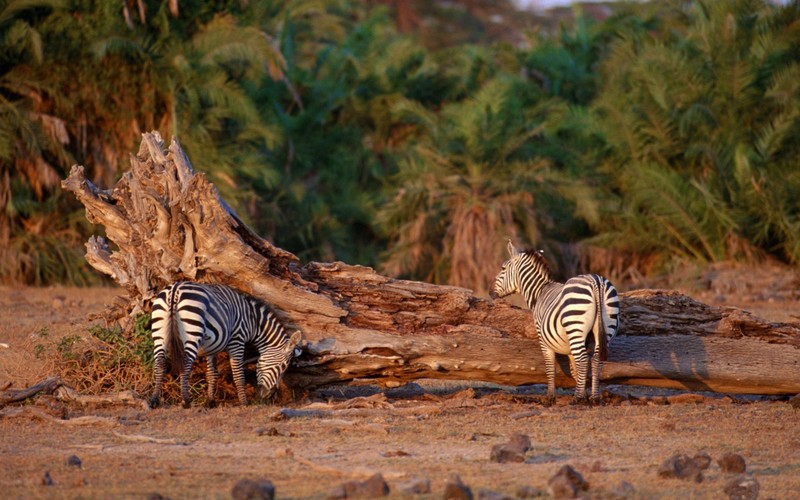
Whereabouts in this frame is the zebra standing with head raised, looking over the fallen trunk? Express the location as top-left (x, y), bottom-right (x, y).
top-left (490, 241), bottom-right (619, 405)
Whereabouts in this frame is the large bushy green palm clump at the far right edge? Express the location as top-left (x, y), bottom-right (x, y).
top-left (594, 0), bottom-right (800, 262)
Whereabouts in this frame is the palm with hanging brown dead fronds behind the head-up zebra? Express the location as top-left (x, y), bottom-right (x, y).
top-left (379, 77), bottom-right (563, 293)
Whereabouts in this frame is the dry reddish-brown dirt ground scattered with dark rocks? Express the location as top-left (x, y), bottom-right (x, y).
top-left (0, 287), bottom-right (800, 499)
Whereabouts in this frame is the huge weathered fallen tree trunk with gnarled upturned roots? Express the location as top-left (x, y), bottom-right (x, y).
top-left (62, 133), bottom-right (800, 394)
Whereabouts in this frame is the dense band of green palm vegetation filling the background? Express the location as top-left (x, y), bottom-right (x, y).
top-left (0, 0), bottom-right (800, 291)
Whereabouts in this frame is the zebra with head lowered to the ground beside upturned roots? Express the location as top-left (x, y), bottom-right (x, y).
top-left (150, 281), bottom-right (301, 408)
